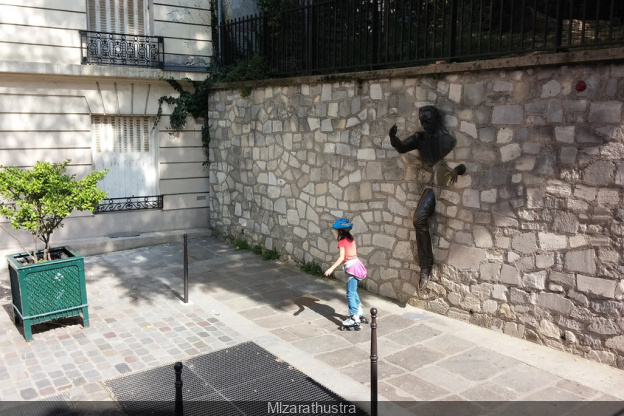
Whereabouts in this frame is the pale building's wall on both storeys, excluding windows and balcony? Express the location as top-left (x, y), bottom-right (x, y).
top-left (0, 0), bottom-right (212, 253)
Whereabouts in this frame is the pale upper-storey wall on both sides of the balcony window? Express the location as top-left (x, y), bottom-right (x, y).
top-left (0, 0), bottom-right (213, 68)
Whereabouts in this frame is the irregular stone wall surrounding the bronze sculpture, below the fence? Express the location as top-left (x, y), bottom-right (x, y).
top-left (209, 51), bottom-right (624, 368)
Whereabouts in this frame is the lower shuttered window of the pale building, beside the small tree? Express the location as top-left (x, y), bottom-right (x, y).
top-left (91, 116), bottom-right (158, 198)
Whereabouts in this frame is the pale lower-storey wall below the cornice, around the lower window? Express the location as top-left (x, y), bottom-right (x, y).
top-left (0, 70), bottom-right (208, 252)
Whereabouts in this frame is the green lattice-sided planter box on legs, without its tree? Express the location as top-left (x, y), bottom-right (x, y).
top-left (6, 247), bottom-right (89, 341)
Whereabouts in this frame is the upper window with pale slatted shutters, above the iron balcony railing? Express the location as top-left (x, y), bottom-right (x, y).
top-left (87, 0), bottom-right (150, 35)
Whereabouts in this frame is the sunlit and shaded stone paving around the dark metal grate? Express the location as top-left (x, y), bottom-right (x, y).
top-left (0, 232), bottom-right (624, 414)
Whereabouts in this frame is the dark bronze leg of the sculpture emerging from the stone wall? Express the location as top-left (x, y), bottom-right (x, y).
top-left (414, 188), bottom-right (435, 289)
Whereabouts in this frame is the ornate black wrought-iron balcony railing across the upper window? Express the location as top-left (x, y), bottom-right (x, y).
top-left (80, 30), bottom-right (165, 68)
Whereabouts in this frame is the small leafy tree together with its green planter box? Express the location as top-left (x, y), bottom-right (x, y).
top-left (0, 160), bottom-right (107, 341)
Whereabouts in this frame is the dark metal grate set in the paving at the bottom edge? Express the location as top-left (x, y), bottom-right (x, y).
top-left (105, 342), bottom-right (365, 416)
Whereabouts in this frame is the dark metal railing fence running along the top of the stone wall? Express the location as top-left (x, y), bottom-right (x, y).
top-left (219, 0), bottom-right (624, 75)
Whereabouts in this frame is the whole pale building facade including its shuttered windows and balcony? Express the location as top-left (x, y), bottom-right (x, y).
top-left (0, 0), bottom-right (213, 251)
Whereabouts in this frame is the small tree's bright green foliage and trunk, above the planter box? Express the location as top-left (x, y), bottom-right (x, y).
top-left (0, 159), bottom-right (108, 263)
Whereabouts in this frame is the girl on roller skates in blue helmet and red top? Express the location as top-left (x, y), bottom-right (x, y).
top-left (325, 218), bottom-right (368, 329)
